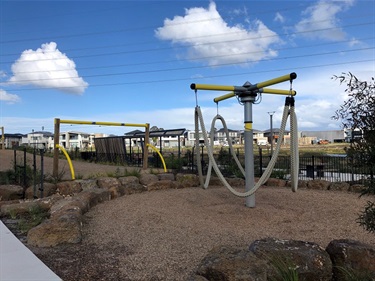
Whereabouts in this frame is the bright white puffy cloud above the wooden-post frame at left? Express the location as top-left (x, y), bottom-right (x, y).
top-left (8, 42), bottom-right (88, 94)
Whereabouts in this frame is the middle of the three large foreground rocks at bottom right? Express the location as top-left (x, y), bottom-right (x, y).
top-left (249, 238), bottom-right (332, 281)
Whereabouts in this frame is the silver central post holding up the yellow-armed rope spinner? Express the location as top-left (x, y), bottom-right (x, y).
top-left (241, 96), bottom-right (255, 208)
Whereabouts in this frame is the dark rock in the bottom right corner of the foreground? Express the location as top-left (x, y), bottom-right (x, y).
top-left (326, 239), bottom-right (375, 280)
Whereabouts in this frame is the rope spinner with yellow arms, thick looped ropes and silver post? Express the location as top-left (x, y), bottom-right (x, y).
top-left (190, 72), bottom-right (299, 207)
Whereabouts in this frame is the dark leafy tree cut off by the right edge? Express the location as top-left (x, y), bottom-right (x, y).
top-left (333, 72), bottom-right (375, 233)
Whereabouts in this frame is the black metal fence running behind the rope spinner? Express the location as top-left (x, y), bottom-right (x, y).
top-left (76, 147), bottom-right (375, 183)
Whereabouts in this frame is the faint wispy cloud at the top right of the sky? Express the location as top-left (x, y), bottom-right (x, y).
top-left (296, 0), bottom-right (354, 41)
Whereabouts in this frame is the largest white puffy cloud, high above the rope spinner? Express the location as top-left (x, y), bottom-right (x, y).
top-left (155, 2), bottom-right (281, 66)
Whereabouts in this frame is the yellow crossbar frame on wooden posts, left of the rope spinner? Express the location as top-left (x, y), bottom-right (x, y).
top-left (53, 118), bottom-right (150, 179)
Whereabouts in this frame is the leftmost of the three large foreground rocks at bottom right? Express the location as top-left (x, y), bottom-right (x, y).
top-left (194, 246), bottom-right (272, 281)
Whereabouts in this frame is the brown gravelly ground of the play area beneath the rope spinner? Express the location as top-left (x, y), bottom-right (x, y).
top-left (0, 151), bottom-right (375, 281)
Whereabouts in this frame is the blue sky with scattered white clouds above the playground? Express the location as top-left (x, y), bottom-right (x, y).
top-left (0, 0), bottom-right (375, 135)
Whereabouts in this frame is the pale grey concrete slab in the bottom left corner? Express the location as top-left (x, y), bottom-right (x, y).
top-left (0, 221), bottom-right (62, 281)
